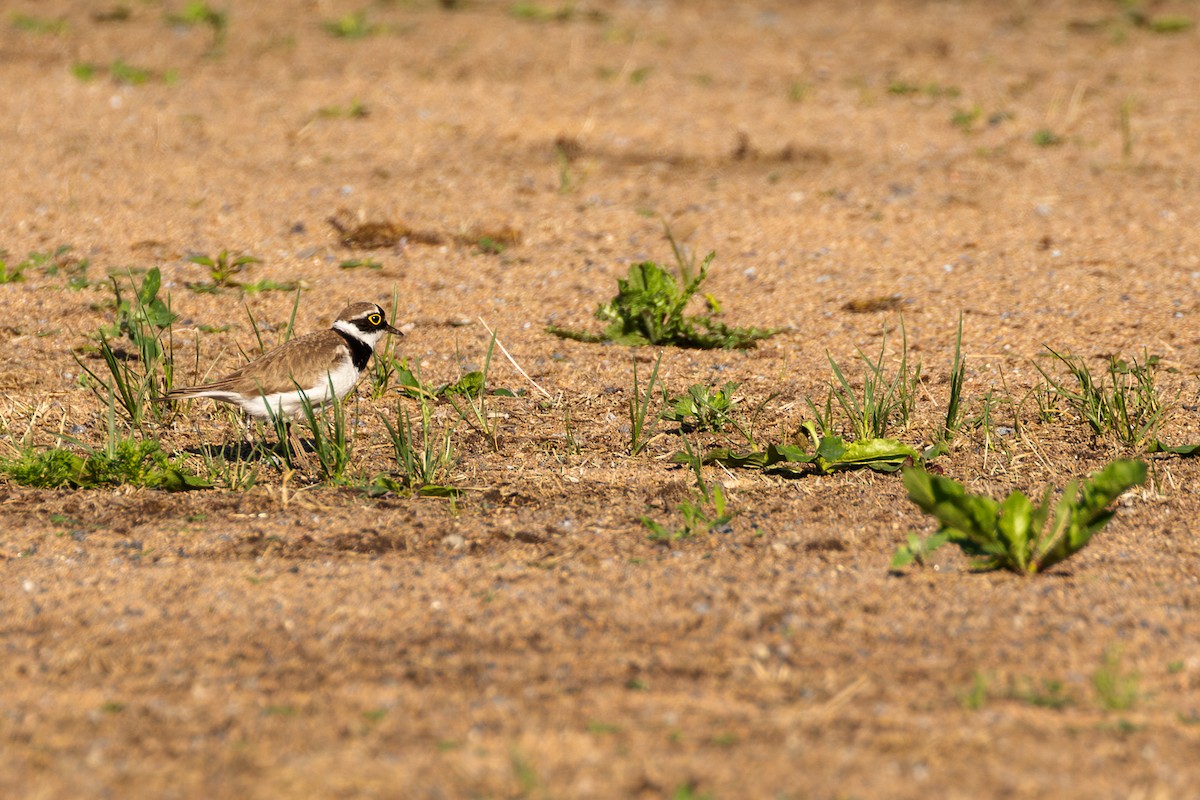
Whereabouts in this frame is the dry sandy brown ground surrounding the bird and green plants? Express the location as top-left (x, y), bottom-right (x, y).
top-left (0, 0), bottom-right (1200, 799)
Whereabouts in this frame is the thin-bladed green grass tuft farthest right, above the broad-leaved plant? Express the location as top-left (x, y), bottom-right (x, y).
top-left (1034, 348), bottom-right (1170, 447)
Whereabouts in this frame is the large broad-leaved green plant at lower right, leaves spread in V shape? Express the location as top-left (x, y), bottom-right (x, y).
top-left (893, 461), bottom-right (1146, 575)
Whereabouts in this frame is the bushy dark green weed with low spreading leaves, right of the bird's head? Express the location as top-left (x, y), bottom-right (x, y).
top-left (546, 233), bottom-right (780, 349)
